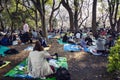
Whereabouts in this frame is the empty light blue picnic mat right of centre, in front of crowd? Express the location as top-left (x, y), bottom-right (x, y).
top-left (63, 44), bottom-right (81, 51)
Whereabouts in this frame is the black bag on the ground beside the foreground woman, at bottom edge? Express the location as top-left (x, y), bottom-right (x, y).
top-left (56, 67), bottom-right (71, 80)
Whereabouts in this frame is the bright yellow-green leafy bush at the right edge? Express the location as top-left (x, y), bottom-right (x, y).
top-left (107, 39), bottom-right (120, 72)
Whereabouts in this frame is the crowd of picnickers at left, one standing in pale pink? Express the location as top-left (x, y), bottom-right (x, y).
top-left (0, 21), bottom-right (48, 47)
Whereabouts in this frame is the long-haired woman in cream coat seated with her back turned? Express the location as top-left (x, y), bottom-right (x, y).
top-left (28, 41), bottom-right (53, 78)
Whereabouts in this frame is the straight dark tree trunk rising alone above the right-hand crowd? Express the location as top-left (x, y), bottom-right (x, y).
top-left (92, 0), bottom-right (97, 37)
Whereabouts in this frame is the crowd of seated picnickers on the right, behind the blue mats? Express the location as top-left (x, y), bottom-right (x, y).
top-left (61, 27), bottom-right (115, 54)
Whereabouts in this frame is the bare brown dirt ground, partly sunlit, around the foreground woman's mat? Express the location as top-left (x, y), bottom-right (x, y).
top-left (0, 39), bottom-right (115, 80)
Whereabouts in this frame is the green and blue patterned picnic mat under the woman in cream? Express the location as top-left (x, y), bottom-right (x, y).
top-left (4, 57), bottom-right (68, 80)
